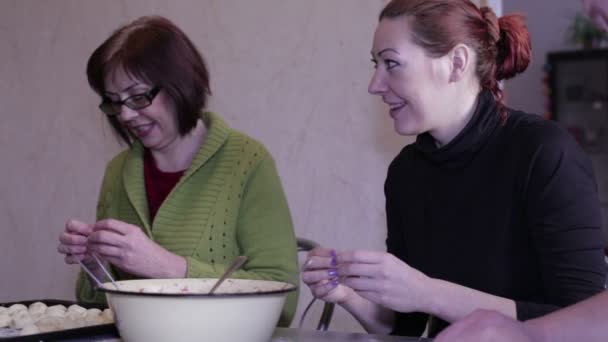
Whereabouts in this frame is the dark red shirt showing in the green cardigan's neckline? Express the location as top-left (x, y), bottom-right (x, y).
top-left (144, 150), bottom-right (184, 222)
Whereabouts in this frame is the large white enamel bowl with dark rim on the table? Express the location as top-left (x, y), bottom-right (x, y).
top-left (99, 279), bottom-right (296, 342)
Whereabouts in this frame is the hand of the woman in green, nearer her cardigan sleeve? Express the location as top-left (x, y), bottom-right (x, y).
top-left (88, 219), bottom-right (186, 278)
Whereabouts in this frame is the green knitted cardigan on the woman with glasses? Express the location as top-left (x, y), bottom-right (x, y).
top-left (76, 112), bottom-right (299, 326)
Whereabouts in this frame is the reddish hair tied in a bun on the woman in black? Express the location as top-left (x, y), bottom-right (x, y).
top-left (379, 0), bottom-right (532, 121)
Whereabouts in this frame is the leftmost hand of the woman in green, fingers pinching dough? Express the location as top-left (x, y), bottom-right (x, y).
top-left (57, 219), bottom-right (97, 268)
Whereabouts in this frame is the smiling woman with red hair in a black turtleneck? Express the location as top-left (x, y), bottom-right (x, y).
top-left (302, 0), bottom-right (606, 336)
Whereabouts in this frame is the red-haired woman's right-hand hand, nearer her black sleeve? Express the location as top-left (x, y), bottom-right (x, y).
top-left (337, 251), bottom-right (431, 312)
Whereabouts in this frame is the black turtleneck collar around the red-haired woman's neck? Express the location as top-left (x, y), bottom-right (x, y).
top-left (414, 90), bottom-right (500, 167)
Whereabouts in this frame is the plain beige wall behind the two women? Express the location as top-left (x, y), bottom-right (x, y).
top-left (0, 0), bottom-right (410, 330)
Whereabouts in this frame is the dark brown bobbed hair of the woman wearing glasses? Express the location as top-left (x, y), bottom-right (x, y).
top-left (87, 16), bottom-right (211, 145)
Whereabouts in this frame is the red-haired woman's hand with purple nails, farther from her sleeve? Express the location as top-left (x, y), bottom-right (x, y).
top-left (302, 248), bottom-right (353, 304)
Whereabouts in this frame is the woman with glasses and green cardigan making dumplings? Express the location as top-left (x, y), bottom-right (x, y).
top-left (58, 17), bottom-right (298, 325)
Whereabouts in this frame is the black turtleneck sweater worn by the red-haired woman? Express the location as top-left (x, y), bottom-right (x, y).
top-left (385, 92), bottom-right (606, 336)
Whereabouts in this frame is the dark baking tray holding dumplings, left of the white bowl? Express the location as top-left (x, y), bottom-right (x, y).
top-left (0, 299), bottom-right (120, 342)
